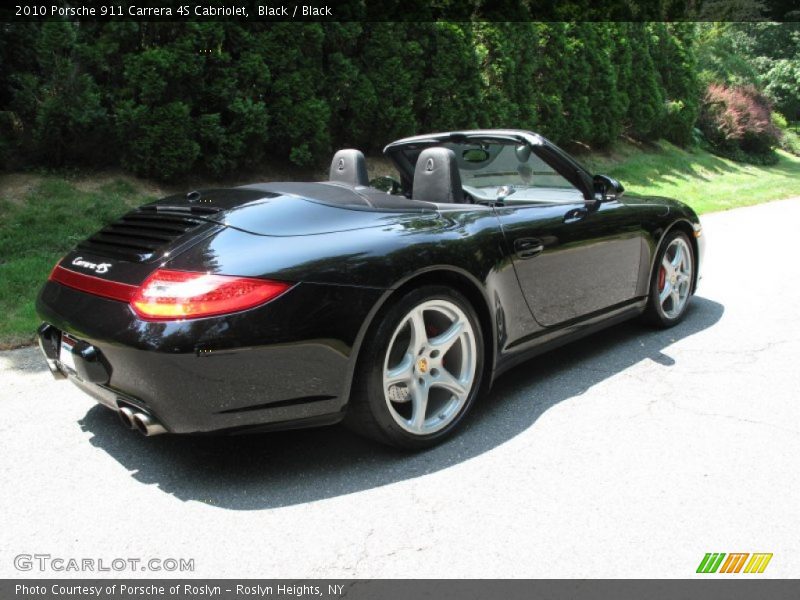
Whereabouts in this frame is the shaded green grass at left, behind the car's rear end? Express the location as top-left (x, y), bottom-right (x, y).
top-left (0, 177), bottom-right (155, 349)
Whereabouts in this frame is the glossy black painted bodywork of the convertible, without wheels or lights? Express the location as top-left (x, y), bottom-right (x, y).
top-left (37, 132), bottom-right (702, 432)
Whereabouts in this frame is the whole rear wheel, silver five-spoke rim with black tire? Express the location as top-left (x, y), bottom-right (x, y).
top-left (345, 286), bottom-right (483, 449)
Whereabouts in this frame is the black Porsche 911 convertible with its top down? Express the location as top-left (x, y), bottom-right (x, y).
top-left (37, 130), bottom-right (704, 448)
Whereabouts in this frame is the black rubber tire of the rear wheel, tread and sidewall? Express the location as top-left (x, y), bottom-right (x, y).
top-left (344, 285), bottom-right (484, 450)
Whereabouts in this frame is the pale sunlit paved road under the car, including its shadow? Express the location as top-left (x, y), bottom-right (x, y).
top-left (0, 199), bottom-right (800, 577)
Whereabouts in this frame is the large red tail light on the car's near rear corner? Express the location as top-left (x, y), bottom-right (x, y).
top-left (130, 269), bottom-right (291, 319)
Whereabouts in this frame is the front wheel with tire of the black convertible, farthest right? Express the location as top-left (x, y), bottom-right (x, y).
top-left (645, 231), bottom-right (695, 327)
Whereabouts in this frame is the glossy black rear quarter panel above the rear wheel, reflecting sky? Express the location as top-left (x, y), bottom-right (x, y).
top-left (169, 208), bottom-right (538, 358)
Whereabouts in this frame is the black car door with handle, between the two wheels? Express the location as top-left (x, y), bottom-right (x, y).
top-left (496, 195), bottom-right (643, 327)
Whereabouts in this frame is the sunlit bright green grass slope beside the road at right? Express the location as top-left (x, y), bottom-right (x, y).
top-left (584, 142), bottom-right (800, 213)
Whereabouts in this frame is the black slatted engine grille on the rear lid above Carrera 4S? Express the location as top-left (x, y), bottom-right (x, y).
top-left (78, 205), bottom-right (219, 262)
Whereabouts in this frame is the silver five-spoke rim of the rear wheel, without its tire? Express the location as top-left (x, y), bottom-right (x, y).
top-left (383, 300), bottom-right (477, 435)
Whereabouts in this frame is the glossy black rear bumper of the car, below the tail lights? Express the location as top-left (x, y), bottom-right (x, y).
top-left (37, 282), bottom-right (382, 433)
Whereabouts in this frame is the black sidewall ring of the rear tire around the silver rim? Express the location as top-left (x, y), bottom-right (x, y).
top-left (362, 286), bottom-right (485, 448)
